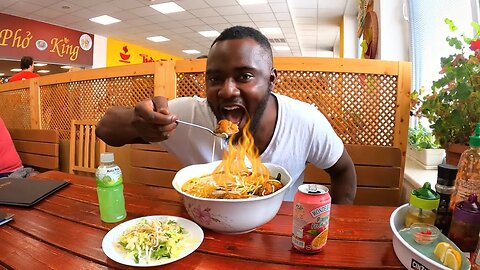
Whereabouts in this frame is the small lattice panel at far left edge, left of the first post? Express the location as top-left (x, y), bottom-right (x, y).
top-left (0, 88), bottom-right (31, 129)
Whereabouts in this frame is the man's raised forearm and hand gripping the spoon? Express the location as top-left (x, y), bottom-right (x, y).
top-left (96, 97), bottom-right (177, 146)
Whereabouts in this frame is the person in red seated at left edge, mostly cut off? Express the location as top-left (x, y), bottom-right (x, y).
top-left (0, 117), bottom-right (23, 178)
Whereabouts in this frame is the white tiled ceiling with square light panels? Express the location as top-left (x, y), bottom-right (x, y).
top-left (0, 0), bottom-right (357, 58)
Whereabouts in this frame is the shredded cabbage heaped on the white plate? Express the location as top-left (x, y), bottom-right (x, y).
top-left (117, 219), bottom-right (188, 264)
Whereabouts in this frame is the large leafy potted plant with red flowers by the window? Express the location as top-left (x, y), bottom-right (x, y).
top-left (412, 19), bottom-right (480, 165)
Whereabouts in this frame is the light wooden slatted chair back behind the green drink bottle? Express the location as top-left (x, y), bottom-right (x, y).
top-left (69, 120), bottom-right (106, 173)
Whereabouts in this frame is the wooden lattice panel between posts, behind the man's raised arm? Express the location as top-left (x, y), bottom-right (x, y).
top-left (40, 75), bottom-right (153, 139)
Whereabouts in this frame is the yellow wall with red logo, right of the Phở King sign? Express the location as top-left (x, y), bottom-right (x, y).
top-left (107, 38), bottom-right (182, 67)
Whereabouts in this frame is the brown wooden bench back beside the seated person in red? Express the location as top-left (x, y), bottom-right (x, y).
top-left (8, 129), bottom-right (60, 171)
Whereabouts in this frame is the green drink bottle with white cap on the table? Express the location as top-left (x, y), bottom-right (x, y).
top-left (96, 152), bottom-right (127, 223)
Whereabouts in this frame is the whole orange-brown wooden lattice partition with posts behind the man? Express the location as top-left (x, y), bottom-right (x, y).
top-left (0, 57), bottom-right (411, 205)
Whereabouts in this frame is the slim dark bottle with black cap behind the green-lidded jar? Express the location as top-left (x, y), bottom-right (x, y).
top-left (435, 164), bottom-right (457, 235)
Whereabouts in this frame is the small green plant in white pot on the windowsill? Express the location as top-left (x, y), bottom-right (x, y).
top-left (407, 124), bottom-right (445, 169)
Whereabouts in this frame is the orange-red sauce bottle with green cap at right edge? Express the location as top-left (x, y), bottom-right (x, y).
top-left (450, 123), bottom-right (480, 211)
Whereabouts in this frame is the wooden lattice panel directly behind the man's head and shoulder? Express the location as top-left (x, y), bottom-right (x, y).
top-left (177, 71), bottom-right (398, 146)
